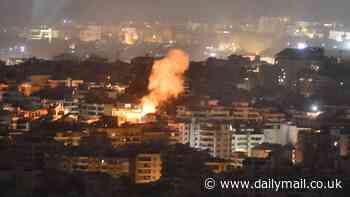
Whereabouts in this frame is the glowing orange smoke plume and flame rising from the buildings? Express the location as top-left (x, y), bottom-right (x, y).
top-left (141, 49), bottom-right (189, 114)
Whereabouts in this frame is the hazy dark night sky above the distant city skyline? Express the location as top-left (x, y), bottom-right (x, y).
top-left (0, 0), bottom-right (350, 24)
